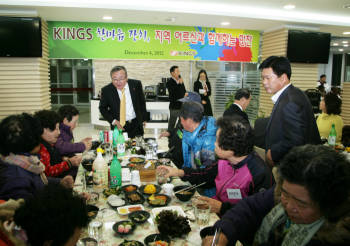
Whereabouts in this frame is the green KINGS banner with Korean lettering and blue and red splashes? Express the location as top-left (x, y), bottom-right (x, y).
top-left (48, 21), bottom-right (260, 62)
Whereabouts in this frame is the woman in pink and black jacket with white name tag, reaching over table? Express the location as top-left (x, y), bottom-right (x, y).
top-left (159, 116), bottom-right (274, 215)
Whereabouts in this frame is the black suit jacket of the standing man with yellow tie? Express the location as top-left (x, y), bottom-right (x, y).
top-left (99, 79), bottom-right (147, 125)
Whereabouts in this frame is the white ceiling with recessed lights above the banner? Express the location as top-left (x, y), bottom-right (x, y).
top-left (0, 0), bottom-right (350, 52)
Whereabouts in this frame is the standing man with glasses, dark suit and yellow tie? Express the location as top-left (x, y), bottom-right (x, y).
top-left (99, 66), bottom-right (147, 138)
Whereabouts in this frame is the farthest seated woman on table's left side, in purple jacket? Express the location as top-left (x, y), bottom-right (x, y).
top-left (55, 105), bottom-right (92, 156)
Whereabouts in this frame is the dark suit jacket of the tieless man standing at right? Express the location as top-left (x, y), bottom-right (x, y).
top-left (265, 85), bottom-right (321, 163)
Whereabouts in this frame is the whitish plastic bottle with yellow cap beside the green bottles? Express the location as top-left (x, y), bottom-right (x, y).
top-left (92, 148), bottom-right (108, 189)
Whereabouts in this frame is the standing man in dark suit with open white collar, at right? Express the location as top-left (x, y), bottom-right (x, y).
top-left (259, 56), bottom-right (321, 166)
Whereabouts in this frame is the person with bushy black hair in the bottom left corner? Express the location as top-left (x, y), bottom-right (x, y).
top-left (0, 185), bottom-right (88, 246)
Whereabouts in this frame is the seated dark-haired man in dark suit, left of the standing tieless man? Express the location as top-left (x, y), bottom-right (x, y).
top-left (223, 88), bottom-right (252, 122)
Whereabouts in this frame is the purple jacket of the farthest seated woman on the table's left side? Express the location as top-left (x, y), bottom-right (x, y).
top-left (55, 123), bottom-right (85, 155)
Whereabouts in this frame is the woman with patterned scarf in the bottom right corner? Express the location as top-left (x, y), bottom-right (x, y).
top-left (202, 145), bottom-right (350, 246)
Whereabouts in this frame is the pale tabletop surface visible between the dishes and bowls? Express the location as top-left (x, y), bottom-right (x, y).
top-left (74, 151), bottom-right (219, 246)
